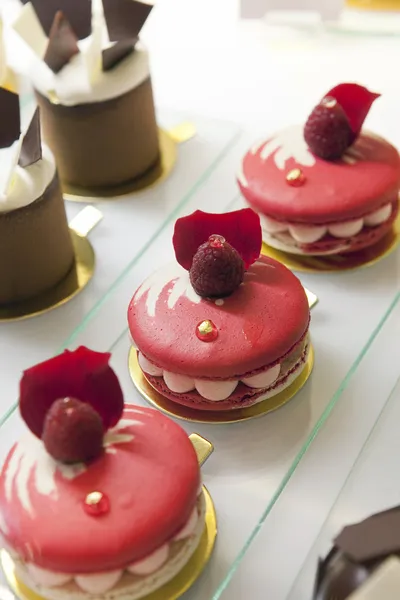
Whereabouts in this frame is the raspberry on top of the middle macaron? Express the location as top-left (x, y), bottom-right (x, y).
top-left (189, 235), bottom-right (244, 298)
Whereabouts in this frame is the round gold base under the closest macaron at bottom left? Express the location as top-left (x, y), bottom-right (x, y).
top-left (0, 486), bottom-right (217, 600)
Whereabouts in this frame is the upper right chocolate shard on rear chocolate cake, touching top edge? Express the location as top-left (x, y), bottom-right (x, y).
top-left (102, 0), bottom-right (153, 42)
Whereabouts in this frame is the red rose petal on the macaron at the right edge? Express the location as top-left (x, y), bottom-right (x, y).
top-left (326, 83), bottom-right (380, 139)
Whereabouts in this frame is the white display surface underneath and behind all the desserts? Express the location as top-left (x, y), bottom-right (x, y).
top-left (0, 0), bottom-right (400, 600)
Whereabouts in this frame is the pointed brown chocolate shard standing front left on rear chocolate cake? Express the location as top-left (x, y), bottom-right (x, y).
top-left (43, 11), bottom-right (79, 73)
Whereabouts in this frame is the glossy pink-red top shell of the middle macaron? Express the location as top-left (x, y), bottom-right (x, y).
top-left (128, 256), bottom-right (310, 379)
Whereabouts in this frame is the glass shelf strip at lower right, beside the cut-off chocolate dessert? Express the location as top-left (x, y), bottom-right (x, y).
top-left (213, 292), bottom-right (400, 600)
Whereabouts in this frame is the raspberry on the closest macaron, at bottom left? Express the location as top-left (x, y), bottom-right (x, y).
top-left (42, 398), bottom-right (104, 463)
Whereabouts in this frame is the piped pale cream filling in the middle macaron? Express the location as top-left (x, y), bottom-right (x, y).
top-left (138, 352), bottom-right (281, 402)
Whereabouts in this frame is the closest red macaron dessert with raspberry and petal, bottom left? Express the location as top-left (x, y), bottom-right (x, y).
top-left (0, 348), bottom-right (205, 600)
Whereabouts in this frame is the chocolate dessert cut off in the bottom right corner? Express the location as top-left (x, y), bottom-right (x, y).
top-left (313, 506), bottom-right (400, 600)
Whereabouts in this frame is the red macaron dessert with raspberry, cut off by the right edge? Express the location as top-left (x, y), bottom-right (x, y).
top-left (237, 83), bottom-right (400, 255)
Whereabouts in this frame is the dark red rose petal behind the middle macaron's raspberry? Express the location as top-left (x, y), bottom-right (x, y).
top-left (172, 208), bottom-right (262, 271)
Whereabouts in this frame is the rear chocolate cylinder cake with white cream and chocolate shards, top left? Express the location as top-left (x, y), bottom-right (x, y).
top-left (14, 0), bottom-right (159, 190)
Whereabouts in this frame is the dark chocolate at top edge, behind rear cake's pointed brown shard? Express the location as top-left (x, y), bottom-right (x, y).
top-left (21, 0), bottom-right (92, 40)
